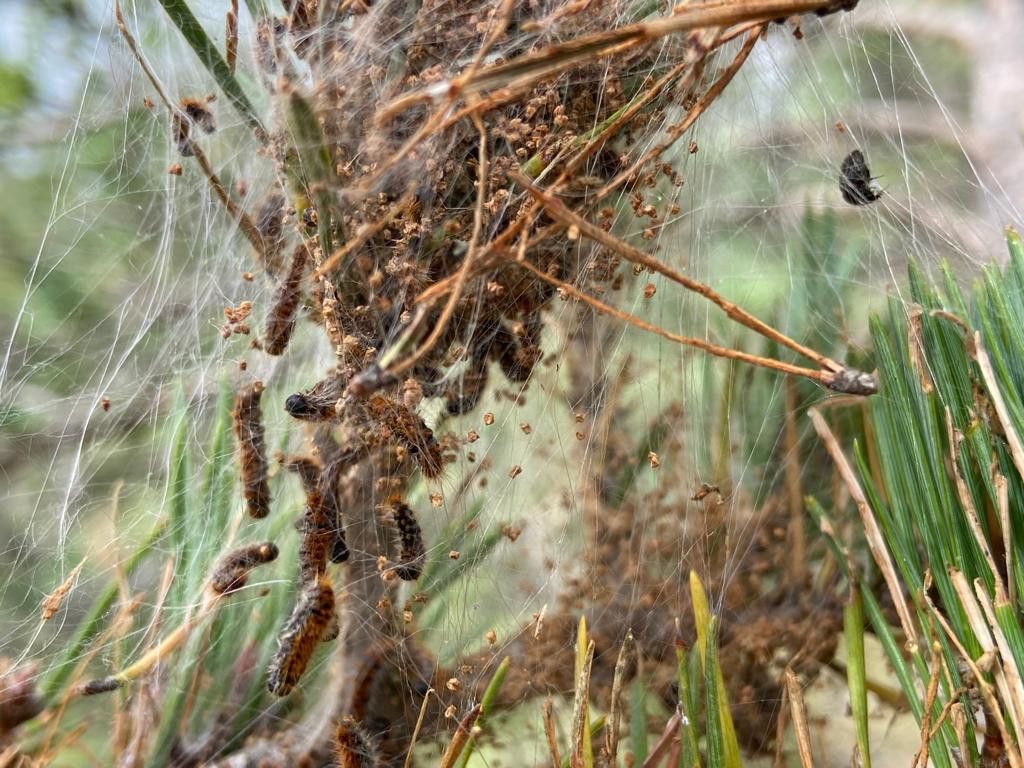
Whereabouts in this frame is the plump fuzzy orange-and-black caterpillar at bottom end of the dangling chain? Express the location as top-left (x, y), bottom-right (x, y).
top-left (266, 578), bottom-right (334, 696)
